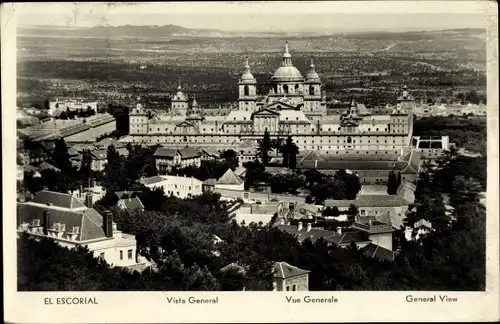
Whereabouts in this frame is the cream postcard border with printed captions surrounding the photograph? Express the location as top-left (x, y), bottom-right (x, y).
top-left (1, 1), bottom-right (500, 323)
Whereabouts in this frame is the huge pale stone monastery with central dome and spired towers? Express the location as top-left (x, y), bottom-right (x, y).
top-left (130, 44), bottom-right (414, 161)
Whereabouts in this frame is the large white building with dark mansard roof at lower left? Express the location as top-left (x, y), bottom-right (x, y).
top-left (17, 190), bottom-right (142, 267)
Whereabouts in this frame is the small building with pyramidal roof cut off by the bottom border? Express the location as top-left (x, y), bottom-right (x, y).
top-left (273, 262), bottom-right (311, 291)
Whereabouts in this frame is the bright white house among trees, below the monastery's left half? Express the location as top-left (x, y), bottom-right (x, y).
top-left (140, 175), bottom-right (203, 198)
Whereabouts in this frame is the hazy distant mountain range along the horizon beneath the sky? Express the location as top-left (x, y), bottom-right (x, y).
top-left (18, 25), bottom-right (485, 38)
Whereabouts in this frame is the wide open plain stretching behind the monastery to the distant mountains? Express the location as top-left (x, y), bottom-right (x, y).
top-left (18, 26), bottom-right (486, 109)
